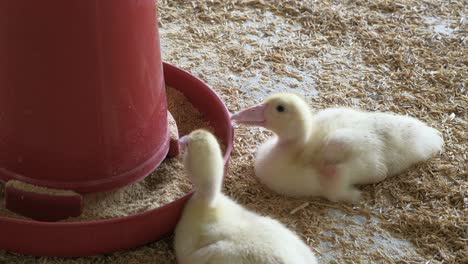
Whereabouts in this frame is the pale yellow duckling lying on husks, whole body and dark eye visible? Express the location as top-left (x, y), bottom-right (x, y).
top-left (231, 93), bottom-right (444, 202)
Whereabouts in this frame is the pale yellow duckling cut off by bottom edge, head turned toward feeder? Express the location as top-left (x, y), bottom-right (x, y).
top-left (174, 130), bottom-right (317, 264)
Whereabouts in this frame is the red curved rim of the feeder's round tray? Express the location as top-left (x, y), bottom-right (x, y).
top-left (0, 64), bottom-right (233, 257)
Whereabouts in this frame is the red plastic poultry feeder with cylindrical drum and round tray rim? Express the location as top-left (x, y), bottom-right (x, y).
top-left (0, 0), bottom-right (232, 256)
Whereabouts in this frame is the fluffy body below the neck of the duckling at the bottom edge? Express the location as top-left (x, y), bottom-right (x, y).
top-left (176, 195), bottom-right (316, 264)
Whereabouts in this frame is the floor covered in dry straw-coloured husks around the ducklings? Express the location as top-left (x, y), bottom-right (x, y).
top-left (0, 0), bottom-right (468, 264)
